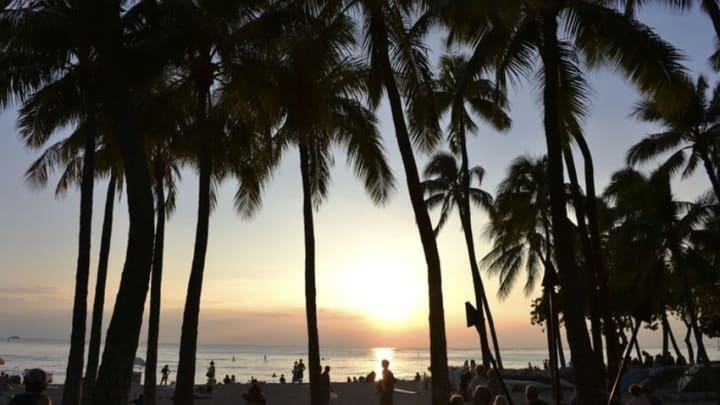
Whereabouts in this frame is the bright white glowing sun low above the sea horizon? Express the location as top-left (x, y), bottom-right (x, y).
top-left (343, 261), bottom-right (424, 326)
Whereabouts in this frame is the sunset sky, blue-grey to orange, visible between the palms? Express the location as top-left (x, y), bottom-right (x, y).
top-left (0, 7), bottom-right (716, 348)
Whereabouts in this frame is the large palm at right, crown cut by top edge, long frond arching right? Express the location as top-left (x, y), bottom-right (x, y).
top-left (448, 0), bottom-right (682, 403)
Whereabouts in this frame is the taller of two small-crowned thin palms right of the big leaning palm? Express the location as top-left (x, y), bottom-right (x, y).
top-left (428, 55), bottom-right (510, 369)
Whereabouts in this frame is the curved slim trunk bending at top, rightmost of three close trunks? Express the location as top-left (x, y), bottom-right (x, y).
top-left (574, 134), bottom-right (622, 384)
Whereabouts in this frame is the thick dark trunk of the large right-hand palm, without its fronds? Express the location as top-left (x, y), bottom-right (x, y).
top-left (540, 10), bottom-right (601, 405)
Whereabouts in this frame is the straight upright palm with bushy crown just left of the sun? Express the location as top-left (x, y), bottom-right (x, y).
top-left (268, 6), bottom-right (393, 405)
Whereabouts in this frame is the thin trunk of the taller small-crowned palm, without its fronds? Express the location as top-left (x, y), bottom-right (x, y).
top-left (459, 134), bottom-right (503, 370)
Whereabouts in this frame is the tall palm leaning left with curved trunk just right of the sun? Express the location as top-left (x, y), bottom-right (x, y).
top-left (353, 0), bottom-right (450, 405)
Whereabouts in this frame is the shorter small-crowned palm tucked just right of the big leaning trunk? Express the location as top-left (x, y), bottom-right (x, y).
top-left (422, 152), bottom-right (500, 366)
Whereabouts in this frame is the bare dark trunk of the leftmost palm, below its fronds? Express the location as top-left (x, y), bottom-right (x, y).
top-left (62, 99), bottom-right (97, 405)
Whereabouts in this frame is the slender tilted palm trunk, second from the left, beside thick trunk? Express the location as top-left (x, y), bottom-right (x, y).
top-left (83, 172), bottom-right (117, 398)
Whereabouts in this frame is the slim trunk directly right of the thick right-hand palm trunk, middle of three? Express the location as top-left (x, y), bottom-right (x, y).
top-left (563, 145), bottom-right (605, 380)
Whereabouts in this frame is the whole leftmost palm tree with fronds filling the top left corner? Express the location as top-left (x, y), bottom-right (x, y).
top-left (0, 1), bottom-right (105, 405)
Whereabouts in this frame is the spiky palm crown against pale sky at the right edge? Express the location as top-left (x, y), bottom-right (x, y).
top-left (626, 75), bottom-right (720, 200)
